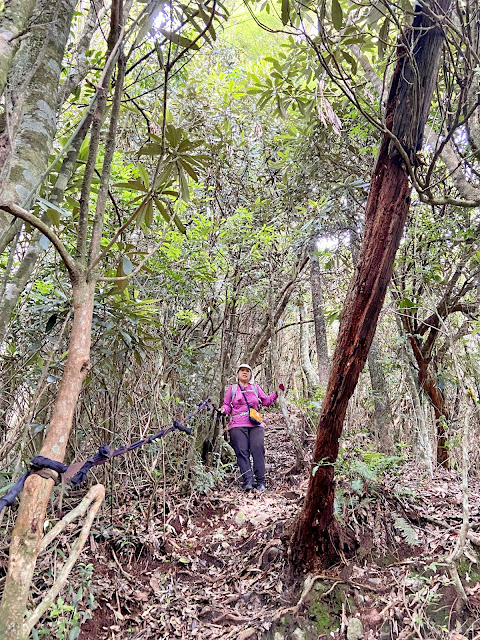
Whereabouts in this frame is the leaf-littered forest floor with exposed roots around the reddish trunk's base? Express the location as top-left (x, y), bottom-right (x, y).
top-left (58, 412), bottom-right (480, 640)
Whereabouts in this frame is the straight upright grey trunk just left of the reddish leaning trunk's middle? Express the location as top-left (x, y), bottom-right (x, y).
top-left (310, 238), bottom-right (330, 389)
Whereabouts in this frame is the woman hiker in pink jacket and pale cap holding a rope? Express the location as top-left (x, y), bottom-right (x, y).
top-left (220, 364), bottom-right (285, 491)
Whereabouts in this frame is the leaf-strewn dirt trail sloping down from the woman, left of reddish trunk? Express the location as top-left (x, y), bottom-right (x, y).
top-left (80, 412), bottom-right (303, 640)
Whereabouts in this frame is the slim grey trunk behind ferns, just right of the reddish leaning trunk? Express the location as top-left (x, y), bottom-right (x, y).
top-left (368, 334), bottom-right (394, 453)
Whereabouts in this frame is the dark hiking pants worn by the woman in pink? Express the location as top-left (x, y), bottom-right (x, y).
top-left (230, 427), bottom-right (265, 486)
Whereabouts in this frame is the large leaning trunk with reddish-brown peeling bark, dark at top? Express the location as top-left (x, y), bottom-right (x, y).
top-left (291, 0), bottom-right (450, 567)
